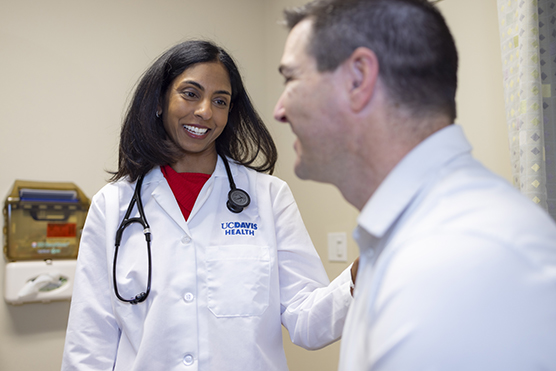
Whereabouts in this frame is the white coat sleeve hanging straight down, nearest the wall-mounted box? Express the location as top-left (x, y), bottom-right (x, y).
top-left (62, 190), bottom-right (120, 371)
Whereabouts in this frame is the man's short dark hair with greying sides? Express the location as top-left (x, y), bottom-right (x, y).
top-left (284, 0), bottom-right (458, 121)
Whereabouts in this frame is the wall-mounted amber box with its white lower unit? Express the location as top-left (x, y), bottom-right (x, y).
top-left (4, 180), bottom-right (90, 304)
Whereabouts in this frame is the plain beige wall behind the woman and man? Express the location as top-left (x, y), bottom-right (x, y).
top-left (0, 0), bottom-right (510, 371)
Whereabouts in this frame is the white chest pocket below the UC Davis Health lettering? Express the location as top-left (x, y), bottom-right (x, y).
top-left (207, 245), bottom-right (270, 317)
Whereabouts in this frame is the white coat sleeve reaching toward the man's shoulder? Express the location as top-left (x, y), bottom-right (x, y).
top-left (274, 184), bottom-right (352, 349)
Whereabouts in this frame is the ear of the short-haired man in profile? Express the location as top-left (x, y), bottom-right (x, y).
top-left (344, 47), bottom-right (379, 112)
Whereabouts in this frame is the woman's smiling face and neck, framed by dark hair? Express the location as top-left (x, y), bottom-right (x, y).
top-left (159, 62), bottom-right (232, 173)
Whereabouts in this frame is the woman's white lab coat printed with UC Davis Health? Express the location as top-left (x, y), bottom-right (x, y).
top-left (62, 158), bottom-right (352, 371)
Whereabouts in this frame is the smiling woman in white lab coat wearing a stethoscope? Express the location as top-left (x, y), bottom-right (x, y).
top-left (62, 41), bottom-right (352, 371)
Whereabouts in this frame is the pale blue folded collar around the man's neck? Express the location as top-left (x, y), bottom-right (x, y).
top-left (357, 124), bottom-right (471, 238)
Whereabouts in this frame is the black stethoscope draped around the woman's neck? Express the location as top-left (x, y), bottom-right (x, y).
top-left (112, 155), bottom-right (251, 304)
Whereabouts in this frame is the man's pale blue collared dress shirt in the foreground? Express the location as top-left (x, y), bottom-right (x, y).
top-left (340, 125), bottom-right (556, 371)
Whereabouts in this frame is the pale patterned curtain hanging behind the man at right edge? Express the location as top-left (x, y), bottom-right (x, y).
top-left (498, 0), bottom-right (556, 219)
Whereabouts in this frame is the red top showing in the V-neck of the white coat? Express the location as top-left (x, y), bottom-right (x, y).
top-left (160, 165), bottom-right (210, 220)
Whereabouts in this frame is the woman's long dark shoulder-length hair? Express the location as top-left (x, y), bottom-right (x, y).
top-left (111, 40), bottom-right (278, 181)
